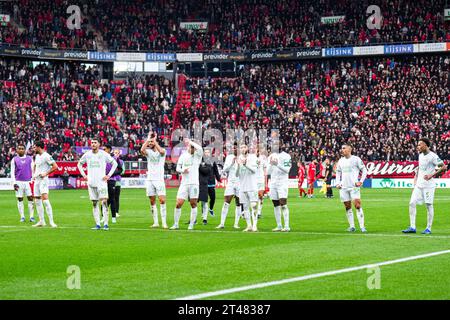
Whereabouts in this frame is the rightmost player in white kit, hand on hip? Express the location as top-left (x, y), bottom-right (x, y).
top-left (403, 138), bottom-right (447, 234)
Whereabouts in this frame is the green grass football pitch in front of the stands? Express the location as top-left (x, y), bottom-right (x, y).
top-left (0, 189), bottom-right (450, 299)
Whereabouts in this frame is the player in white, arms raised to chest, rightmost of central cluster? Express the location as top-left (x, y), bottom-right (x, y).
top-left (267, 151), bottom-right (292, 232)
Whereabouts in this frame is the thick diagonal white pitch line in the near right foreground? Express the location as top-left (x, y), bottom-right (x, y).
top-left (175, 250), bottom-right (450, 300)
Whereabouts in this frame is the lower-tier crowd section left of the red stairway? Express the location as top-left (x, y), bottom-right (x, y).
top-left (0, 60), bottom-right (174, 172)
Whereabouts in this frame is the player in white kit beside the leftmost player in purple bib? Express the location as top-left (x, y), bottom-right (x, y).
top-left (33, 141), bottom-right (58, 228)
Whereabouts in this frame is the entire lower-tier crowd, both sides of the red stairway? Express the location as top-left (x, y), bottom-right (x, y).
top-left (0, 55), bottom-right (450, 178)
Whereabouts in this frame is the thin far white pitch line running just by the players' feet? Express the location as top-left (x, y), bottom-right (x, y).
top-left (0, 226), bottom-right (450, 239)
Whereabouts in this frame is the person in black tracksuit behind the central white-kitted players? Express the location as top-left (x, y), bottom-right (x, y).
top-left (198, 150), bottom-right (220, 224)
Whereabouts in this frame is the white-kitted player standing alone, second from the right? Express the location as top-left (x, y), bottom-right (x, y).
top-left (336, 144), bottom-right (367, 232)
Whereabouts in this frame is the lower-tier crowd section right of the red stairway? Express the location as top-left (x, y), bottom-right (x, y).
top-left (180, 56), bottom-right (450, 160)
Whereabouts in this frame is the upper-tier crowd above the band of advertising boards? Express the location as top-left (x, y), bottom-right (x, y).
top-left (0, 0), bottom-right (450, 51)
